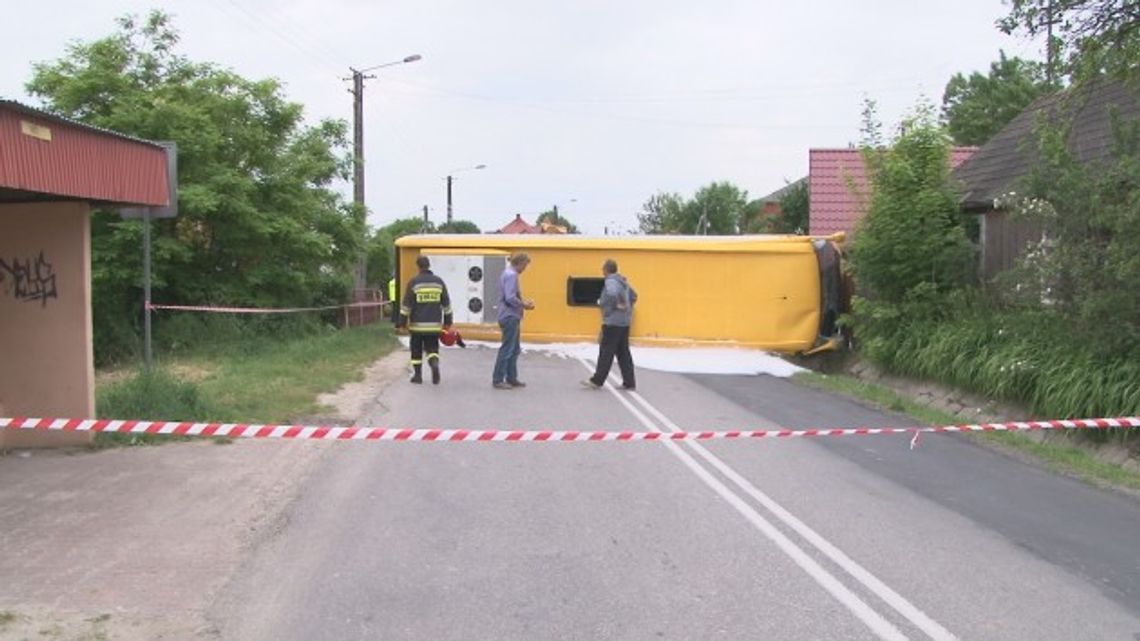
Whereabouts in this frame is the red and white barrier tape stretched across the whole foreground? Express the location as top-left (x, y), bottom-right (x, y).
top-left (0, 416), bottom-right (1140, 447)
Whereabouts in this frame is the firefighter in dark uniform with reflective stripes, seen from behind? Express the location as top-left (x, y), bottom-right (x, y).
top-left (400, 255), bottom-right (451, 386)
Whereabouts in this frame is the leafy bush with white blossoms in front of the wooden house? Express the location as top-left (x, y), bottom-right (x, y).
top-left (1002, 89), bottom-right (1140, 353)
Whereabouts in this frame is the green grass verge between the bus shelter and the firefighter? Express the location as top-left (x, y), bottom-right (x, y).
top-left (96, 324), bottom-right (398, 445)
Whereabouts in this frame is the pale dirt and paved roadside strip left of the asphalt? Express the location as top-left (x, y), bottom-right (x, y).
top-left (0, 352), bottom-right (406, 641)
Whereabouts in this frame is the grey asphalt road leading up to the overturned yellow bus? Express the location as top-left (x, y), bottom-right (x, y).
top-left (212, 349), bottom-right (1140, 641)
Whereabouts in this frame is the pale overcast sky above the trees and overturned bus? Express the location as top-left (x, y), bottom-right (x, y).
top-left (0, 0), bottom-right (1040, 233)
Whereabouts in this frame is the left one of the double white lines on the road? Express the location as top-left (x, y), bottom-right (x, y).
top-left (578, 358), bottom-right (907, 641)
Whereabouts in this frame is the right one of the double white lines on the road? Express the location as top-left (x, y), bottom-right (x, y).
top-left (613, 369), bottom-right (956, 641)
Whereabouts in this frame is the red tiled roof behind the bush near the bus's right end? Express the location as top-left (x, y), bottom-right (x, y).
top-left (808, 147), bottom-right (977, 235)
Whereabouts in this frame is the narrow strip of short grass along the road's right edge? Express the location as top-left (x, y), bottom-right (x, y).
top-left (796, 372), bottom-right (1140, 489)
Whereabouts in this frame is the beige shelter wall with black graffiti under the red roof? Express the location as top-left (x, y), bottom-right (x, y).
top-left (0, 203), bottom-right (95, 448)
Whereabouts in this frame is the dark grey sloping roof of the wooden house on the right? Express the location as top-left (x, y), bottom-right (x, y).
top-left (953, 81), bottom-right (1140, 209)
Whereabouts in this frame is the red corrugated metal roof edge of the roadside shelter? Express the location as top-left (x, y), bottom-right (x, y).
top-left (0, 100), bottom-right (170, 206)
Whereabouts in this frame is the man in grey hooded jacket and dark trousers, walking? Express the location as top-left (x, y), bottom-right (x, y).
top-left (581, 259), bottom-right (637, 391)
